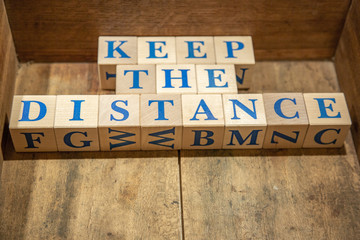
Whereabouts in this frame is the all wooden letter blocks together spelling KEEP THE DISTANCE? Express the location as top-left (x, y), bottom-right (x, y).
top-left (10, 37), bottom-right (351, 152)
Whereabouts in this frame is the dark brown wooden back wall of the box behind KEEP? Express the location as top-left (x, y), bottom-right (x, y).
top-left (5, 0), bottom-right (350, 62)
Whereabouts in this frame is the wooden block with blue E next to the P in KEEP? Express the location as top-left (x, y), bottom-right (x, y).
top-left (176, 37), bottom-right (215, 64)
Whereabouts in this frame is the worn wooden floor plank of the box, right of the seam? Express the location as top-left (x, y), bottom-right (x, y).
top-left (181, 62), bottom-right (360, 239)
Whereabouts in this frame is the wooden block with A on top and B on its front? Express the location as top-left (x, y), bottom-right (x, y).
top-left (182, 94), bottom-right (224, 149)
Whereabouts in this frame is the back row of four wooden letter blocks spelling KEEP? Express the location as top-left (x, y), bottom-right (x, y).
top-left (98, 36), bottom-right (255, 89)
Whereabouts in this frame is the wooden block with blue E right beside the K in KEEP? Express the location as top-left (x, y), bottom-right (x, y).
top-left (138, 37), bottom-right (176, 64)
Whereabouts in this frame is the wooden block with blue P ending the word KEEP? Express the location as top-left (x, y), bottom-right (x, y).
top-left (214, 36), bottom-right (255, 89)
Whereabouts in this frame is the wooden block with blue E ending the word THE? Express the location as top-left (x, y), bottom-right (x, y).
top-left (196, 64), bottom-right (238, 94)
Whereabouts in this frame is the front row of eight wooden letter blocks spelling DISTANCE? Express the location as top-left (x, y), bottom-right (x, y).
top-left (10, 93), bottom-right (351, 152)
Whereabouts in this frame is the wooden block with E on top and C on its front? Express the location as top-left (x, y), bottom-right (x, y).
top-left (303, 93), bottom-right (351, 148)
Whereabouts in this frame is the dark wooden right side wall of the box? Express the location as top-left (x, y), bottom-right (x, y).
top-left (335, 0), bottom-right (360, 161)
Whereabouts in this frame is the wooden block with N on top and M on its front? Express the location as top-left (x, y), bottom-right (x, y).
top-left (223, 94), bottom-right (267, 149)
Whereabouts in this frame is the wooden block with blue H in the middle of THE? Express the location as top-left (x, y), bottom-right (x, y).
top-left (156, 64), bottom-right (197, 94)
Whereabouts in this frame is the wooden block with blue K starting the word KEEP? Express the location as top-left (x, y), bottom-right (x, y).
top-left (98, 36), bottom-right (137, 90)
